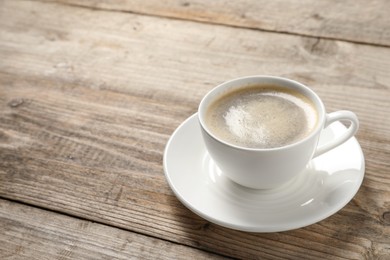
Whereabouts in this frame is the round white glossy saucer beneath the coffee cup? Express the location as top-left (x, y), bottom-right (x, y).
top-left (164, 114), bottom-right (364, 232)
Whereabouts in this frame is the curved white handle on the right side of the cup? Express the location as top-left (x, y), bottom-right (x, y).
top-left (313, 110), bottom-right (359, 158)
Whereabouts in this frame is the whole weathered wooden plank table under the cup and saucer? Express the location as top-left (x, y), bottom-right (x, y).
top-left (0, 0), bottom-right (390, 260)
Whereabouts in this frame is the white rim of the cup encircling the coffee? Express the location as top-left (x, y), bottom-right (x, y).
top-left (198, 75), bottom-right (326, 152)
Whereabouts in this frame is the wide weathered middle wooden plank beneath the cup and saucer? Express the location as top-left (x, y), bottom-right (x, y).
top-left (0, 0), bottom-right (390, 259)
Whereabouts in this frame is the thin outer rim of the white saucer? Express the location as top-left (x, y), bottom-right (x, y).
top-left (163, 113), bottom-right (365, 233)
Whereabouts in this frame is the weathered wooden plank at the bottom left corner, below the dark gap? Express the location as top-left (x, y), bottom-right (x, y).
top-left (0, 199), bottom-right (229, 260)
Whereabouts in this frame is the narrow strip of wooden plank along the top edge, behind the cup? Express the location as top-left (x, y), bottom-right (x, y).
top-left (42, 0), bottom-right (390, 46)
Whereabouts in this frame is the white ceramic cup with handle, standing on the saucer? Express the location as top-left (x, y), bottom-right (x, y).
top-left (198, 76), bottom-right (359, 189)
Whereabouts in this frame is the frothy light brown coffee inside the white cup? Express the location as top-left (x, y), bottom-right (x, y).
top-left (205, 85), bottom-right (318, 148)
